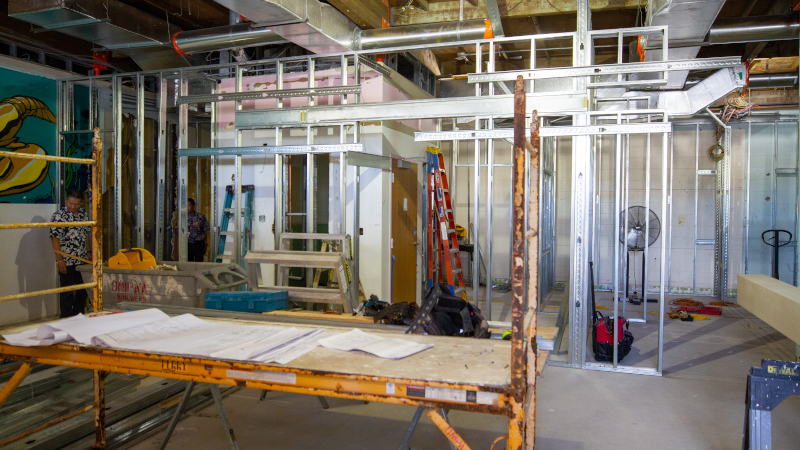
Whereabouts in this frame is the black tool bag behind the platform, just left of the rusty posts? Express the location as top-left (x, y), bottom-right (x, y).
top-left (423, 284), bottom-right (489, 339)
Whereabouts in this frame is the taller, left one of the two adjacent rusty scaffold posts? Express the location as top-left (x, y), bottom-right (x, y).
top-left (508, 76), bottom-right (535, 450)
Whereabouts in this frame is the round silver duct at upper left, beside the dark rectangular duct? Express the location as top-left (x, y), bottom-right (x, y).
top-left (172, 23), bottom-right (287, 55)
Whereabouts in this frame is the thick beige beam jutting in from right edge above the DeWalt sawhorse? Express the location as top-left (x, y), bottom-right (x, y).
top-left (736, 275), bottom-right (800, 343)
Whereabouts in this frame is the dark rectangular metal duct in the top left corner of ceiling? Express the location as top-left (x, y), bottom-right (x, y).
top-left (8, 0), bottom-right (189, 70)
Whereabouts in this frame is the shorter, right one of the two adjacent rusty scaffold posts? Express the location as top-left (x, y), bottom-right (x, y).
top-left (524, 110), bottom-right (541, 449)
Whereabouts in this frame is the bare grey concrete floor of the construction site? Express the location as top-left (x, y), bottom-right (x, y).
top-left (128, 292), bottom-right (800, 450)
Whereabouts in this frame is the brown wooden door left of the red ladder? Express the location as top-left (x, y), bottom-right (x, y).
top-left (390, 158), bottom-right (419, 303)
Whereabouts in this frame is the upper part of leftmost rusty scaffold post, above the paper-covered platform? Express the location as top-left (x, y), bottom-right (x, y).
top-left (91, 127), bottom-right (105, 312)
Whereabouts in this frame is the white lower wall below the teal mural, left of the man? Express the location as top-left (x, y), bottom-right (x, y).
top-left (0, 203), bottom-right (58, 325)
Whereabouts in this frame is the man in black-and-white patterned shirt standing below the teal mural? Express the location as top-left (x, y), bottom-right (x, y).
top-left (50, 191), bottom-right (92, 317)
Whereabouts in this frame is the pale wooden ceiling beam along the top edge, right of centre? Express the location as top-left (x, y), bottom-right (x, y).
top-left (390, 0), bottom-right (641, 26)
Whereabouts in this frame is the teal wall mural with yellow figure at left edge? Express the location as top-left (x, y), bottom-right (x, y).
top-left (0, 69), bottom-right (58, 203)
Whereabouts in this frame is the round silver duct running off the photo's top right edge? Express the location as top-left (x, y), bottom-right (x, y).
top-left (705, 14), bottom-right (800, 45)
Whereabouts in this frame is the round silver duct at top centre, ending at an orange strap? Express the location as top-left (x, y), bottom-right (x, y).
top-left (353, 19), bottom-right (494, 50)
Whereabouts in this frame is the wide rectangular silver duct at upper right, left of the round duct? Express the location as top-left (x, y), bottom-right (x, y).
top-left (639, 0), bottom-right (725, 89)
